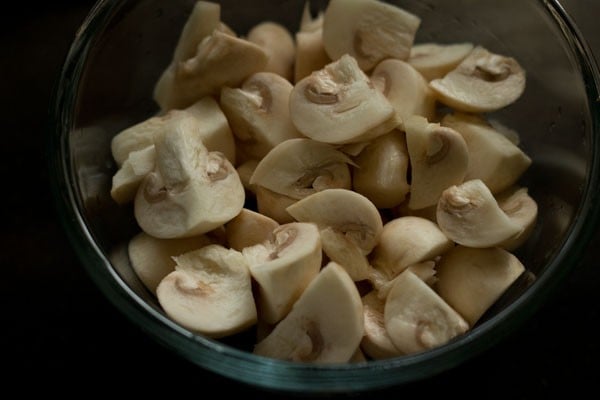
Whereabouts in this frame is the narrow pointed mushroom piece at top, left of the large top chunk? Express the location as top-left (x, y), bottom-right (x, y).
top-left (293, 1), bottom-right (332, 82)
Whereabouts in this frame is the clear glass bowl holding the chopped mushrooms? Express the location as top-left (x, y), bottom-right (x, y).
top-left (49, 0), bottom-right (600, 393)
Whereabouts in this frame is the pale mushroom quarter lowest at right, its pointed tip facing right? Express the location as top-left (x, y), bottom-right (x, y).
top-left (383, 271), bottom-right (469, 354)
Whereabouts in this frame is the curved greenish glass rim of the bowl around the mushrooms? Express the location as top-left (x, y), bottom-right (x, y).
top-left (48, 0), bottom-right (600, 393)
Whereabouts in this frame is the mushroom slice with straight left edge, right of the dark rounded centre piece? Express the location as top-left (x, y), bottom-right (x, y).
top-left (405, 115), bottom-right (469, 209)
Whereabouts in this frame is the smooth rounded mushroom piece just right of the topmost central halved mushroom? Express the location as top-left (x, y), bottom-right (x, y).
top-left (371, 58), bottom-right (436, 124)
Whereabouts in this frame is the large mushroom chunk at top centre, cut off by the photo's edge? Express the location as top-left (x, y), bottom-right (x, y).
top-left (323, 0), bottom-right (421, 71)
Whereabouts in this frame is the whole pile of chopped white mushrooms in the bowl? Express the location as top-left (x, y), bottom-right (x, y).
top-left (106, 0), bottom-right (537, 363)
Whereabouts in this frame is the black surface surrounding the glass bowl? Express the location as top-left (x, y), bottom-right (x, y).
top-left (0, 0), bottom-right (600, 398)
